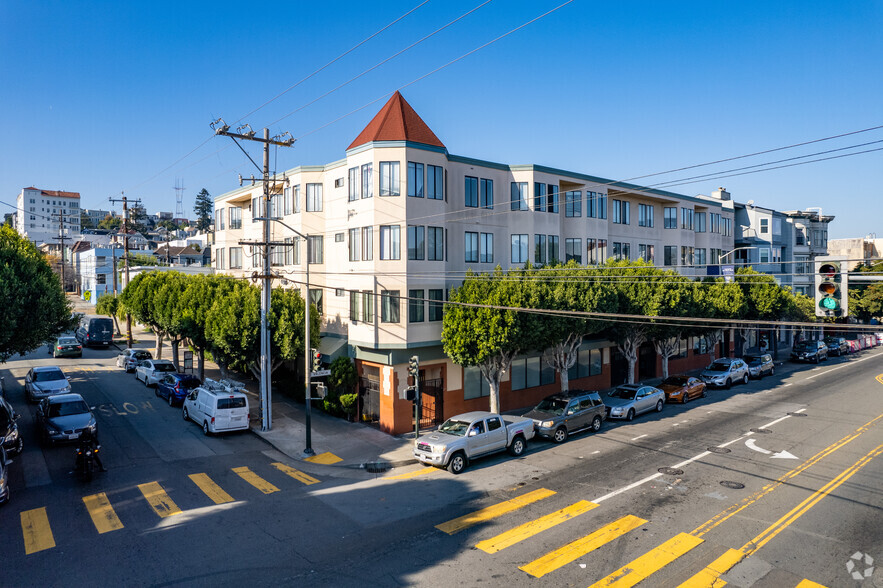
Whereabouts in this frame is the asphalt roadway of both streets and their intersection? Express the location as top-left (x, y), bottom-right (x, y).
top-left (0, 348), bottom-right (883, 587)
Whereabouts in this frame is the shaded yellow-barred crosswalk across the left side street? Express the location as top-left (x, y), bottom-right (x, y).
top-left (20, 462), bottom-right (320, 555)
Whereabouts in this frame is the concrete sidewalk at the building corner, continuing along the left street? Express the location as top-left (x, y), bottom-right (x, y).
top-left (68, 294), bottom-right (417, 473)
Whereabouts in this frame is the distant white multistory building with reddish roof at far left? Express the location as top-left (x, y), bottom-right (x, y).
top-left (15, 187), bottom-right (80, 246)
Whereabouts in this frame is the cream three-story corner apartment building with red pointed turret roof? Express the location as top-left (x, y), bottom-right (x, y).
top-left (213, 93), bottom-right (733, 433)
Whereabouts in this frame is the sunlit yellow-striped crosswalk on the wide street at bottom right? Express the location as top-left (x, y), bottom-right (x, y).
top-left (436, 488), bottom-right (824, 588)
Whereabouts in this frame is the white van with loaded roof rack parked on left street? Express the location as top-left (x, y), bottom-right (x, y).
top-left (181, 378), bottom-right (248, 435)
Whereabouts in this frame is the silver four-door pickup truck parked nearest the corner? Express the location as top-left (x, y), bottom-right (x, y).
top-left (414, 411), bottom-right (534, 474)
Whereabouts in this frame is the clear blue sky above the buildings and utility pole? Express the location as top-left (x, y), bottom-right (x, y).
top-left (0, 0), bottom-right (883, 238)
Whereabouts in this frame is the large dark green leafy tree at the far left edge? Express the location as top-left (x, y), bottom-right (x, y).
top-left (0, 226), bottom-right (78, 362)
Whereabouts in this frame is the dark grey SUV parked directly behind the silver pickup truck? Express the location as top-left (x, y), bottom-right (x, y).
top-left (524, 390), bottom-right (607, 443)
